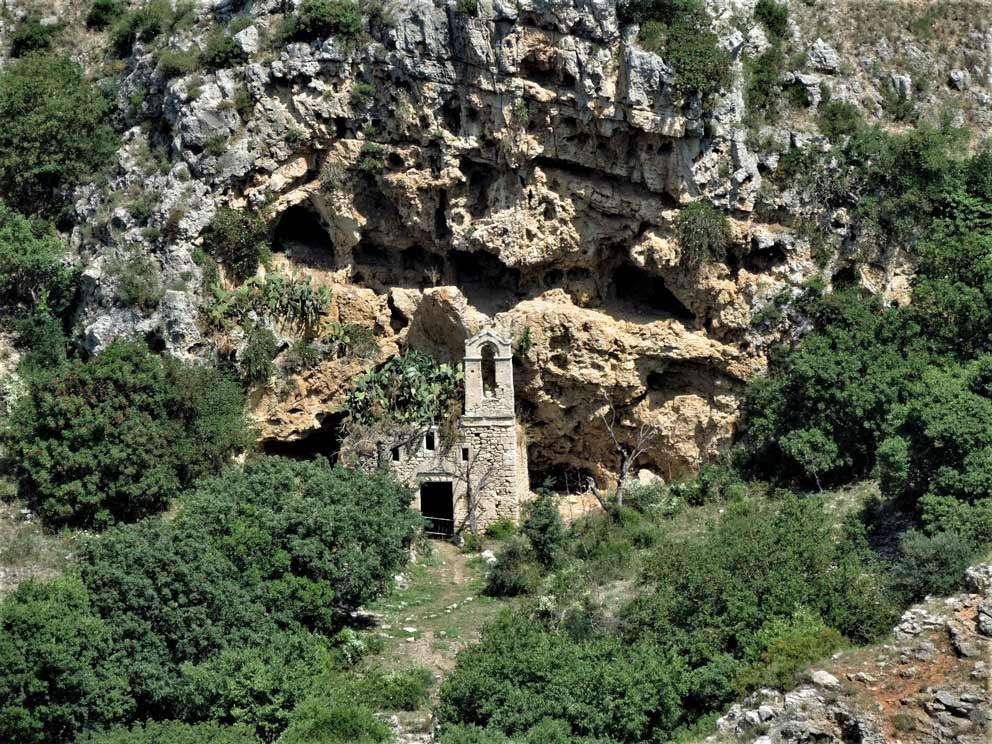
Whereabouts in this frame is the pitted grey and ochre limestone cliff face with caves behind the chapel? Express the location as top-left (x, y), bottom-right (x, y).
top-left (38, 0), bottom-right (992, 478)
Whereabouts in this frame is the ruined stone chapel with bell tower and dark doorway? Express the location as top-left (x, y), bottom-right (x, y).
top-left (364, 329), bottom-right (530, 536)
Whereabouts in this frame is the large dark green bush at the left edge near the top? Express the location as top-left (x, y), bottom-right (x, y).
top-left (0, 54), bottom-right (117, 214)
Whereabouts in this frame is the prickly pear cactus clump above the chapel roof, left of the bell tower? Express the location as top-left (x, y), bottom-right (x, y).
top-left (348, 351), bottom-right (463, 424)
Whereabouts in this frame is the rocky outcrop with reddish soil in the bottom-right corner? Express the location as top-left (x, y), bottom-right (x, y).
top-left (707, 564), bottom-right (992, 744)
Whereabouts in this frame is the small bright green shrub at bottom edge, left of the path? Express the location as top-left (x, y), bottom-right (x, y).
top-left (279, 697), bottom-right (393, 744)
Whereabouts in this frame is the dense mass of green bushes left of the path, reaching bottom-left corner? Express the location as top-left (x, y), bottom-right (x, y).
top-left (0, 458), bottom-right (418, 744)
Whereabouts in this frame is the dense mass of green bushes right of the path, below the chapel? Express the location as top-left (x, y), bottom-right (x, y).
top-left (439, 496), bottom-right (899, 742)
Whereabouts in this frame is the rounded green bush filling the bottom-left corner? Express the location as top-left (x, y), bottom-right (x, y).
top-left (0, 577), bottom-right (132, 744)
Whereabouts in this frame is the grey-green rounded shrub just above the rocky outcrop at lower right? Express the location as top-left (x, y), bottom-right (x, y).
top-left (894, 530), bottom-right (976, 601)
